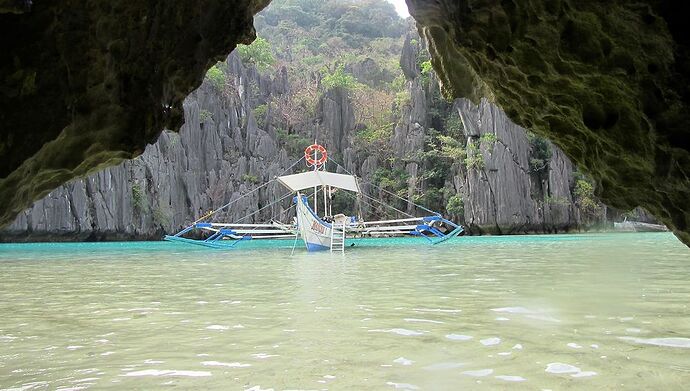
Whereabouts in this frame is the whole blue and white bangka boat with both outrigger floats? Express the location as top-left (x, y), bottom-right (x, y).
top-left (164, 144), bottom-right (463, 252)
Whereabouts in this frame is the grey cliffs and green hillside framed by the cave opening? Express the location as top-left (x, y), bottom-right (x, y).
top-left (0, 0), bottom-right (676, 242)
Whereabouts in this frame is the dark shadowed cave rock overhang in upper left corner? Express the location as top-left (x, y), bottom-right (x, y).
top-left (0, 0), bottom-right (269, 228)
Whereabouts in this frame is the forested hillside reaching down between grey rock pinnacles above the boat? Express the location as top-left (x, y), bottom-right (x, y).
top-left (251, 0), bottom-right (409, 158)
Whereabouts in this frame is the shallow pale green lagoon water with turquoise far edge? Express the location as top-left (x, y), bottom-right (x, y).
top-left (0, 233), bottom-right (690, 390)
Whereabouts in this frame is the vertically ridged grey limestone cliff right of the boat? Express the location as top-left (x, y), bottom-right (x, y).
top-left (455, 99), bottom-right (579, 234)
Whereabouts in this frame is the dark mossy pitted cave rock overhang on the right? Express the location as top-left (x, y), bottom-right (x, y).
top-left (407, 0), bottom-right (690, 245)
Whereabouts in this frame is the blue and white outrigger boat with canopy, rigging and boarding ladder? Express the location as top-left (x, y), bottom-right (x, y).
top-left (165, 143), bottom-right (462, 250)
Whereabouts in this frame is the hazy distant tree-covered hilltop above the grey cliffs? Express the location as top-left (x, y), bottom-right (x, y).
top-left (250, 0), bottom-right (406, 84)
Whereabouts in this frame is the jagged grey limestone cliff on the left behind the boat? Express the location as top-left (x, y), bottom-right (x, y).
top-left (2, 55), bottom-right (292, 240)
